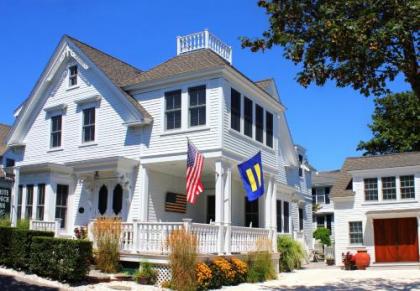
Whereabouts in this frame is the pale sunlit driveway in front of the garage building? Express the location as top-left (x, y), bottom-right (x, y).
top-left (224, 267), bottom-right (420, 291)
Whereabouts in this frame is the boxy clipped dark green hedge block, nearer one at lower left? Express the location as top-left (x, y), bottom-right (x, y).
top-left (29, 237), bottom-right (92, 282)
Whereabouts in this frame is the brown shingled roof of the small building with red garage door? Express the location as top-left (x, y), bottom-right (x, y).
top-left (331, 152), bottom-right (420, 197)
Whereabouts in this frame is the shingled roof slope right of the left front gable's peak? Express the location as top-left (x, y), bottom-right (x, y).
top-left (65, 35), bottom-right (152, 119)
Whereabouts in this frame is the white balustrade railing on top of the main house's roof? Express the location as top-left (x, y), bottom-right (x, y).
top-left (177, 29), bottom-right (232, 64)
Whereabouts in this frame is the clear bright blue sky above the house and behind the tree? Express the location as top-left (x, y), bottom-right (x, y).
top-left (0, 0), bottom-right (409, 170)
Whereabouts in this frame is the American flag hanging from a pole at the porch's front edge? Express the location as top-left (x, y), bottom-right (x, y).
top-left (187, 141), bottom-right (204, 204)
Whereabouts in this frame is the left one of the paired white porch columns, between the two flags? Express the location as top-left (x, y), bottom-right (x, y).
top-left (215, 161), bottom-right (225, 255)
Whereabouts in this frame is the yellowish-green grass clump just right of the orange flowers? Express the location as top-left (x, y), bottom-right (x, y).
top-left (247, 251), bottom-right (277, 283)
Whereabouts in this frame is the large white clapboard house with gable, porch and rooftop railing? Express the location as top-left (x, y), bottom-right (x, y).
top-left (4, 31), bottom-right (312, 262)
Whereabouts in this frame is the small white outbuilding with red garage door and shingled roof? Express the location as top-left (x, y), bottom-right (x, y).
top-left (331, 152), bottom-right (420, 264)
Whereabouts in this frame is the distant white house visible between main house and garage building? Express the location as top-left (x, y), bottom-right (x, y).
top-left (312, 170), bottom-right (340, 238)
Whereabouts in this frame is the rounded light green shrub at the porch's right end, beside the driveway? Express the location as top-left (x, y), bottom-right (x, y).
top-left (277, 236), bottom-right (305, 272)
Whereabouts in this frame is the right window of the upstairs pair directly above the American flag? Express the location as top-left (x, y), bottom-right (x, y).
top-left (188, 86), bottom-right (206, 126)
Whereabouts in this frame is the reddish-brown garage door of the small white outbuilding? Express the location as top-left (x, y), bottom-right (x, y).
top-left (373, 217), bottom-right (419, 263)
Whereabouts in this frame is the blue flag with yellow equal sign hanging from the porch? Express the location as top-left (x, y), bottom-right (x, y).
top-left (238, 152), bottom-right (264, 201)
